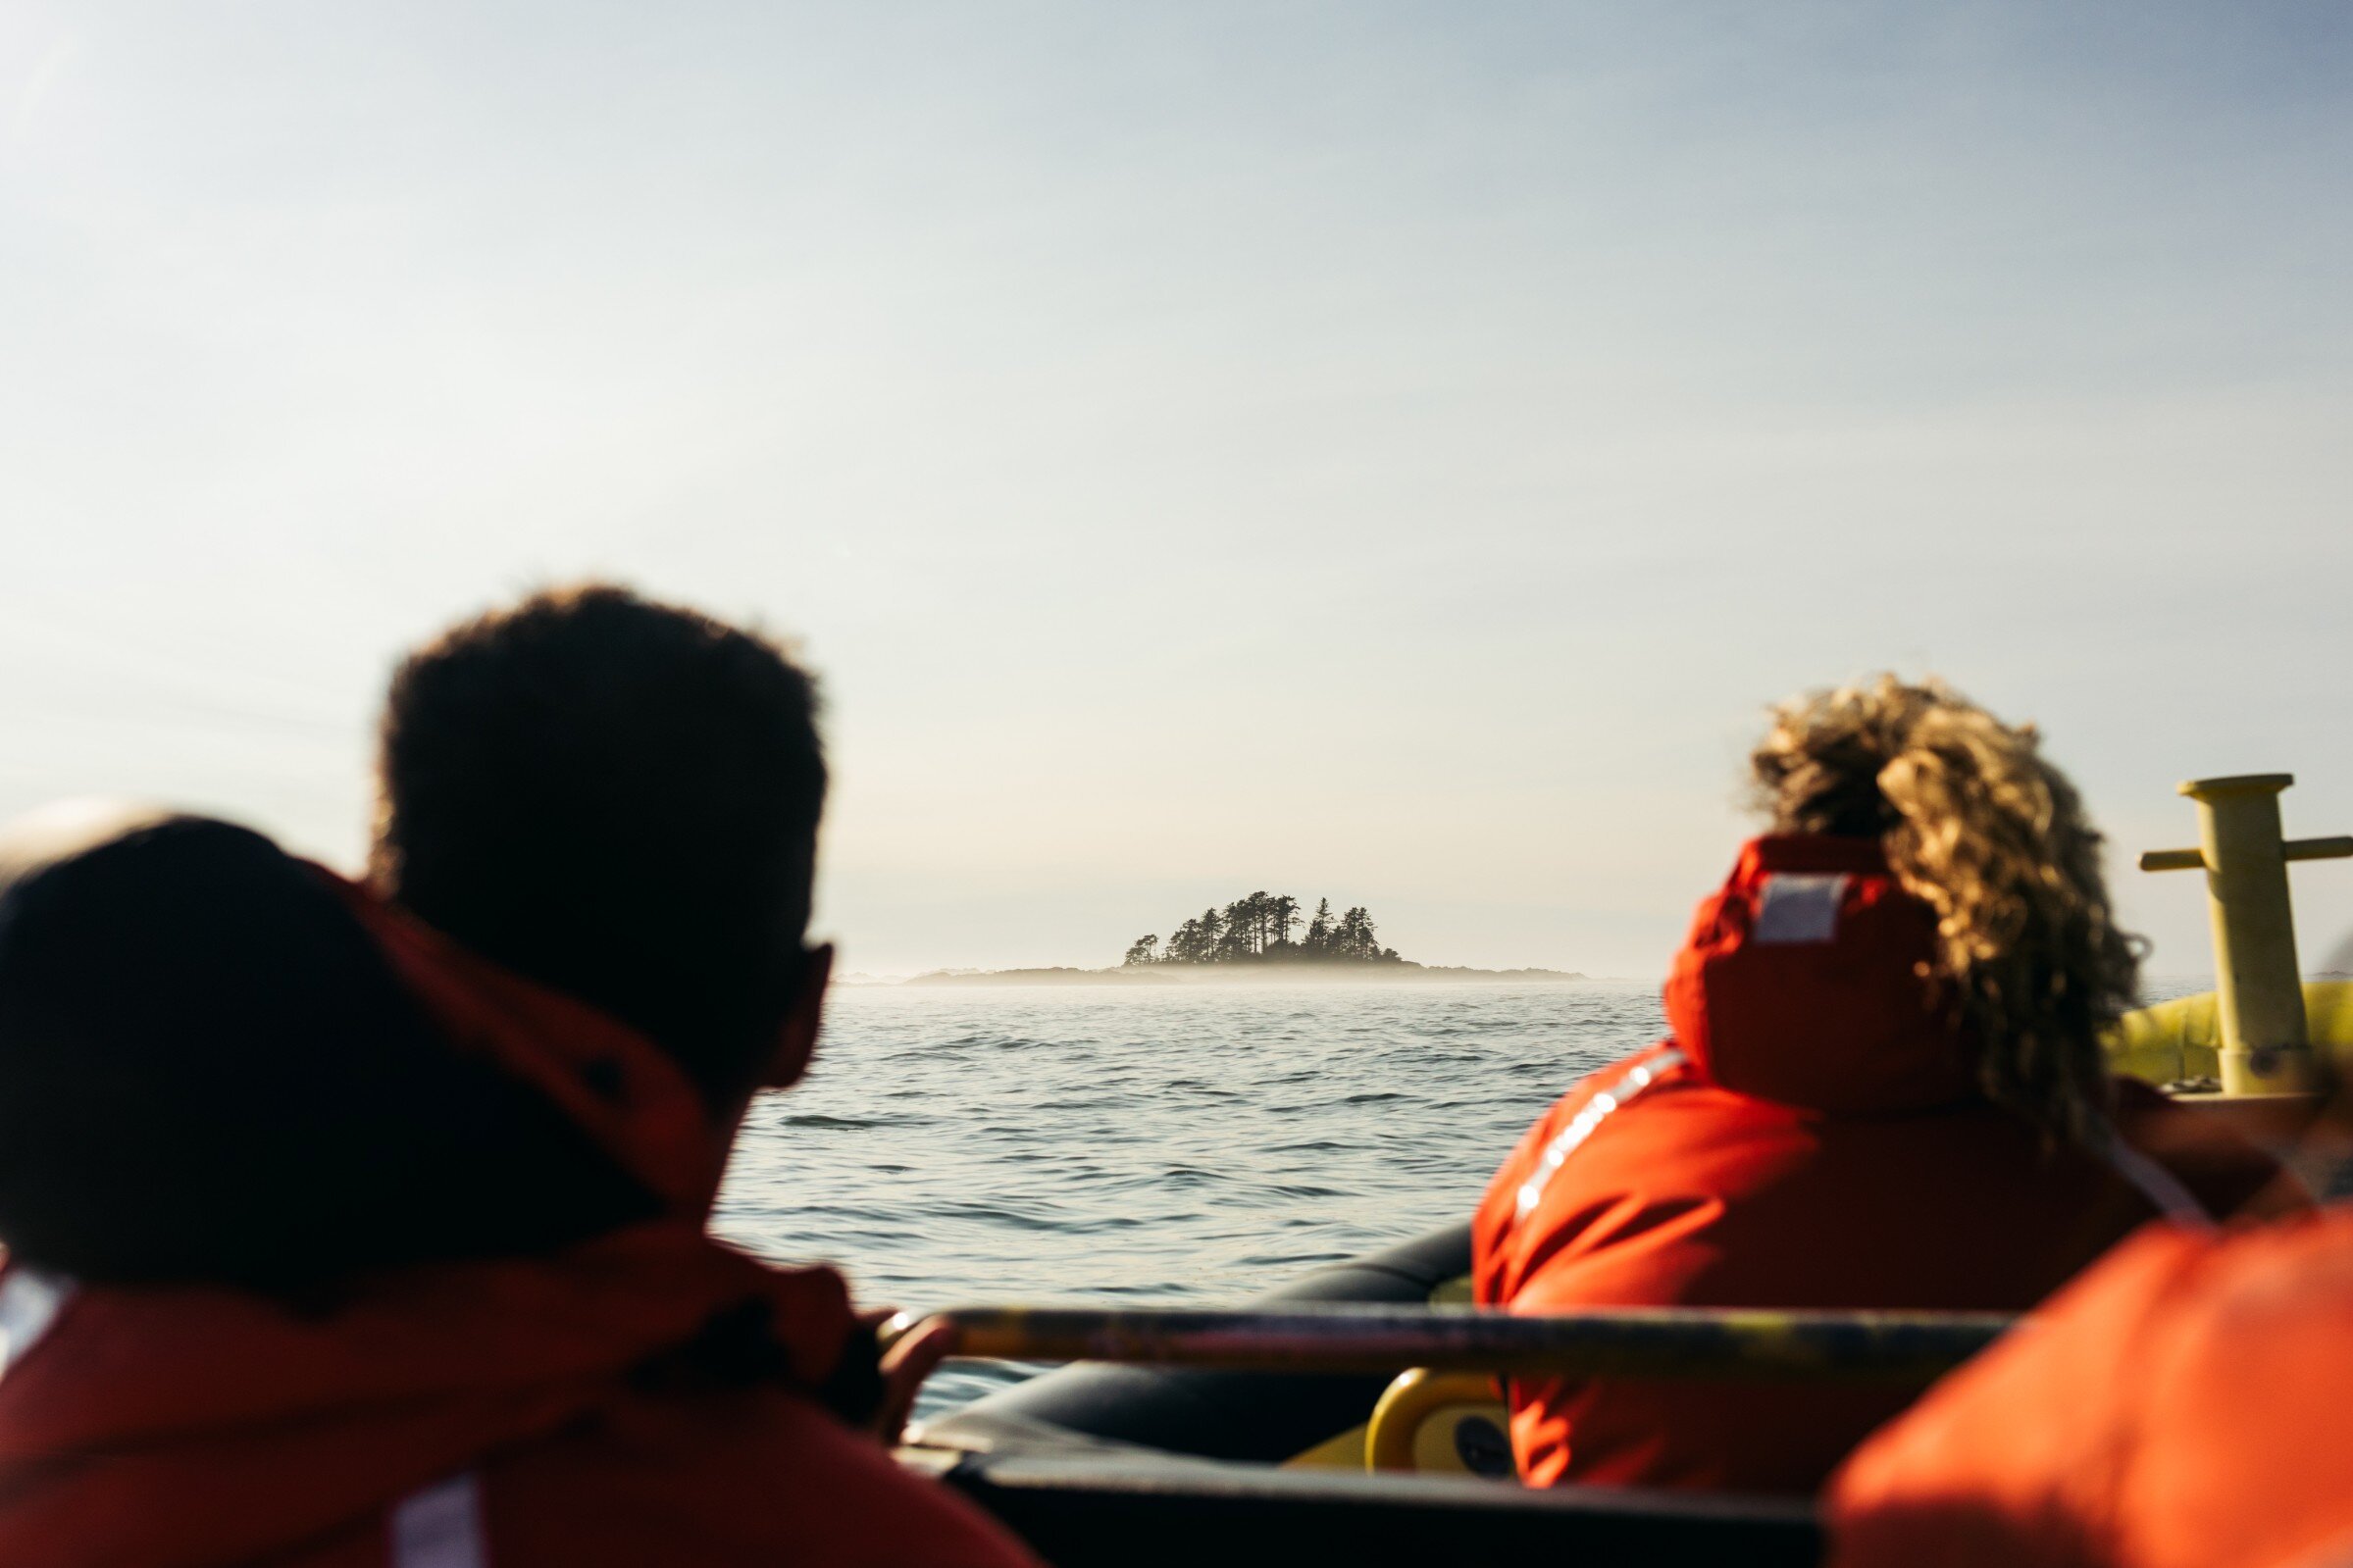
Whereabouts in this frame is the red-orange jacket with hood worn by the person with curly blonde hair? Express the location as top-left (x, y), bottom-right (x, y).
top-left (1473, 835), bottom-right (2277, 1492)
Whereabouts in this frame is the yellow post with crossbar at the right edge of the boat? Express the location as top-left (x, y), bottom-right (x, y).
top-left (2141, 774), bottom-right (2353, 1095)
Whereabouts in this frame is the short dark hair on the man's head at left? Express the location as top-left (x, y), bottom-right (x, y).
top-left (370, 585), bottom-right (826, 1102)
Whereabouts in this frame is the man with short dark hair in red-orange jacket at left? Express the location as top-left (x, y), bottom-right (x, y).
top-left (0, 587), bottom-right (1033, 1568)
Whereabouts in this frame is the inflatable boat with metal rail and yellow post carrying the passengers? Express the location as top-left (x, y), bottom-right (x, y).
top-left (898, 774), bottom-right (2353, 1568)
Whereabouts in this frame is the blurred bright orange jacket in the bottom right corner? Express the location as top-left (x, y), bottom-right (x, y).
top-left (1826, 1211), bottom-right (2353, 1568)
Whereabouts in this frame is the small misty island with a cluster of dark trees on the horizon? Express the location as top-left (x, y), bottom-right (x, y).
top-left (906, 893), bottom-right (1586, 985)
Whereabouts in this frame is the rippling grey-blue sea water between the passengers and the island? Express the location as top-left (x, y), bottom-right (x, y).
top-left (720, 981), bottom-right (1663, 1413)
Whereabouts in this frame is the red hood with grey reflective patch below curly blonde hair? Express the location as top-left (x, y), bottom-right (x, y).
top-left (1665, 835), bottom-right (1979, 1112)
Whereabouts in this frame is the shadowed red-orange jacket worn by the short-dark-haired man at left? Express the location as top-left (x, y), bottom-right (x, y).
top-left (0, 872), bottom-right (1031, 1568)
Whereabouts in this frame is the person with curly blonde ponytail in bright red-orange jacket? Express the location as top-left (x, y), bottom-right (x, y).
top-left (1473, 677), bottom-right (2299, 1492)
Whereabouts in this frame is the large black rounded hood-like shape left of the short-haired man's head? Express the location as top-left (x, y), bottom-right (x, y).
top-left (0, 816), bottom-right (661, 1293)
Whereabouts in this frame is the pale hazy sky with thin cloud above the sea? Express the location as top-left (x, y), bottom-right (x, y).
top-left (0, 0), bottom-right (2353, 976)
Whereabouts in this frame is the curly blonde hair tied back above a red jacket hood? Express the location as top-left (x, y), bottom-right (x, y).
top-left (1748, 675), bottom-right (2141, 1142)
